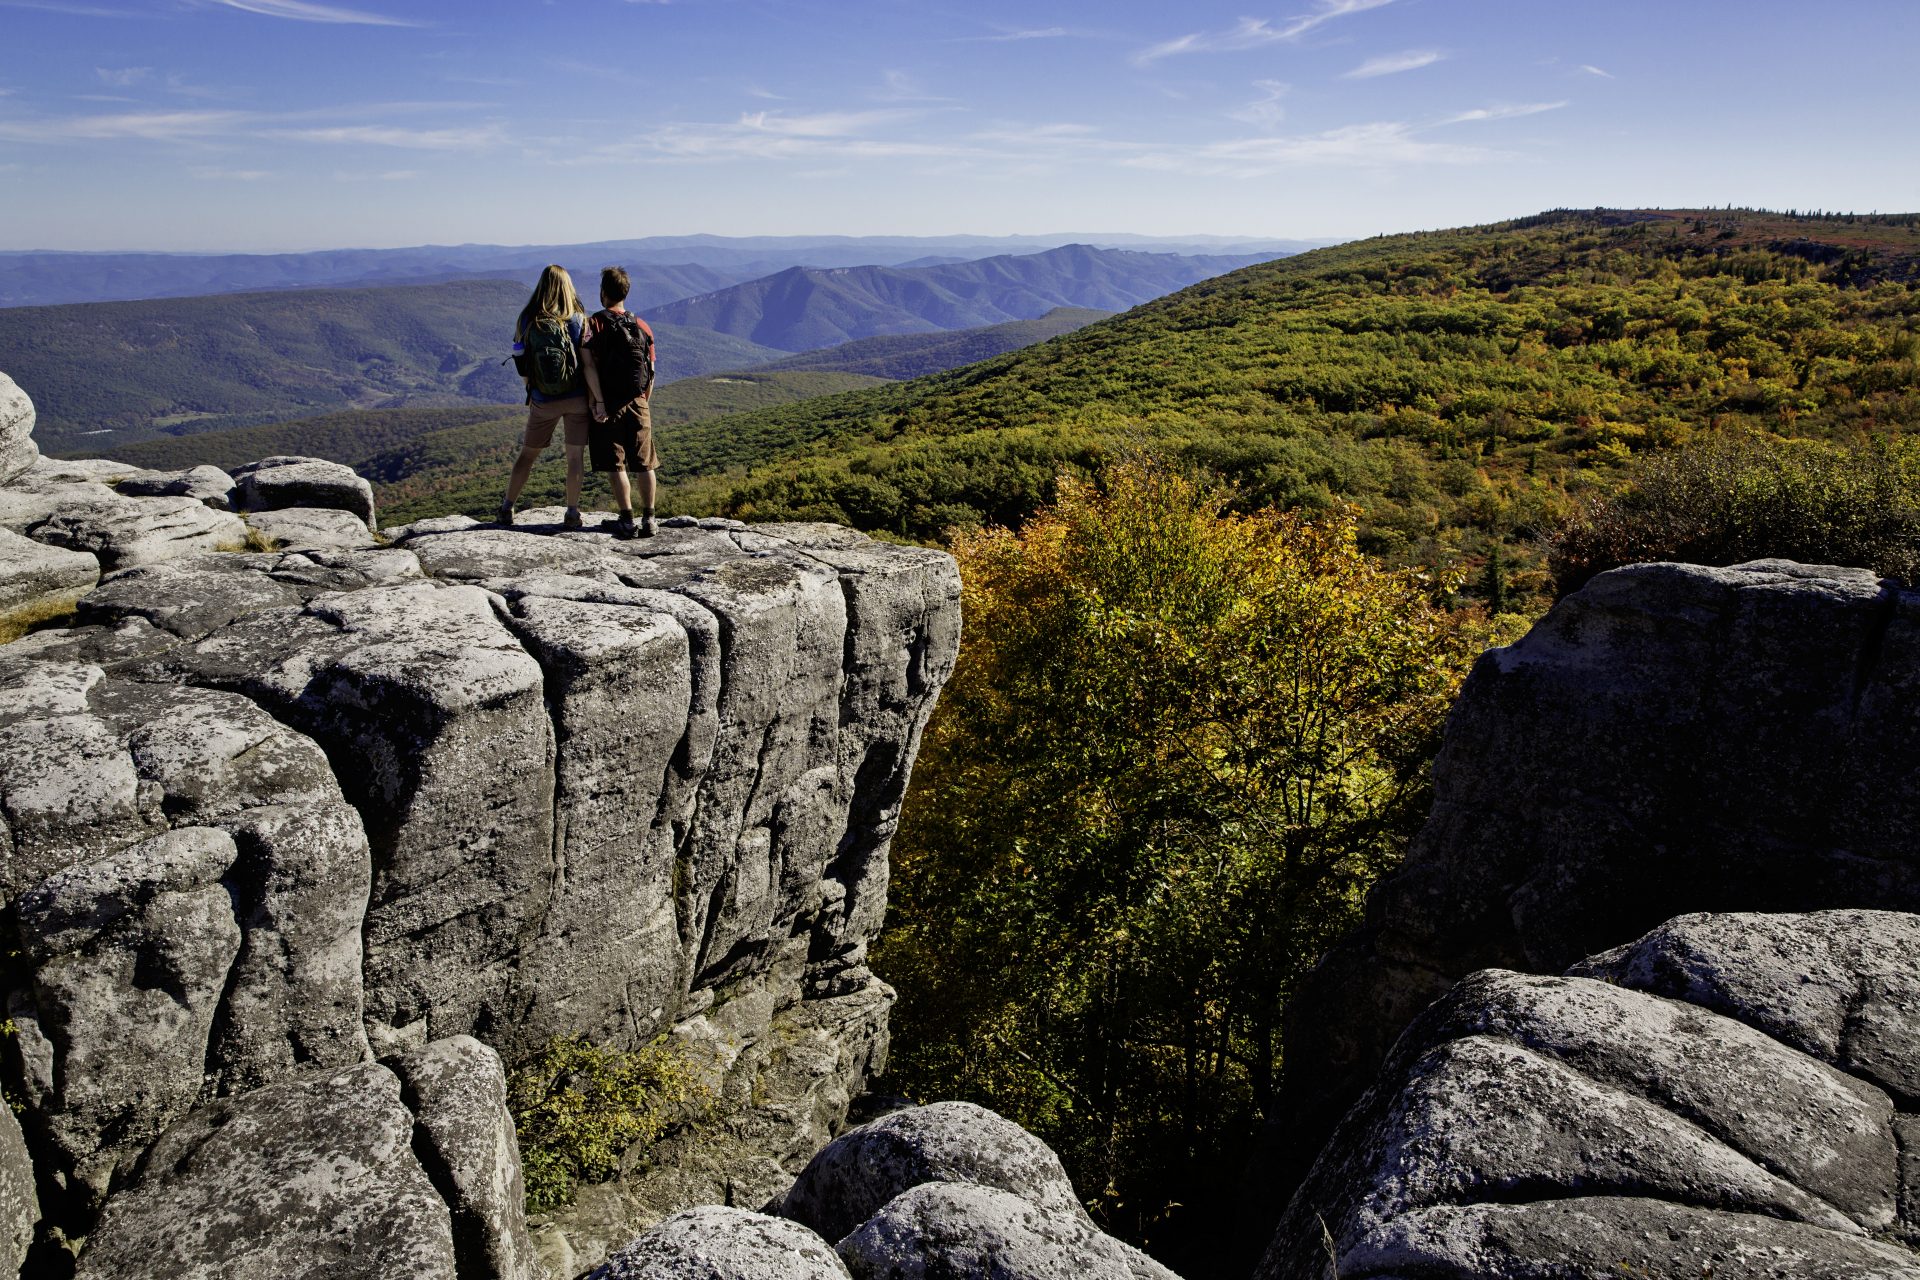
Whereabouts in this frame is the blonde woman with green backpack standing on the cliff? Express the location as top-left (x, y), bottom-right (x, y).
top-left (499, 265), bottom-right (601, 530)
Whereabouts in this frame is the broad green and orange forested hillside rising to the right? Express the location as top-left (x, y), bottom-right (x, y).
top-left (652, 211), bottom-right (1920, 610)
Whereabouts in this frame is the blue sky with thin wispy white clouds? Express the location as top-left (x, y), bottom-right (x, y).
top-left (0, 0), bottom-right (1920, 251)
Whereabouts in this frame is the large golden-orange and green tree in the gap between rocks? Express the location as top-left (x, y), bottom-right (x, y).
top-left (876, 464), bottom-right (1473, 1253)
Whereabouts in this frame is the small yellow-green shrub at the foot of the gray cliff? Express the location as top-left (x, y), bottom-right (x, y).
top-left (507, 1036), bottom-right (712, 1213)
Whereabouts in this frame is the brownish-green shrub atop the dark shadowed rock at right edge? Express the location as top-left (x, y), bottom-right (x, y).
top-left (1548, 436), bottom-right (1920, 595)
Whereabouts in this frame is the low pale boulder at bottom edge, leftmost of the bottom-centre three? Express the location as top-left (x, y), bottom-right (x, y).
top-left (589, 1205), bottom-right (847, 1280)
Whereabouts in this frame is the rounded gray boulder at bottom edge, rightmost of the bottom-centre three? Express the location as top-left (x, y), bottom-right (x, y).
top-left (839, 1182), bottom-right (1179, 1280)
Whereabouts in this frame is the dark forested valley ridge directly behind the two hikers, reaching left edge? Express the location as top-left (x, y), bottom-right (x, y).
top-left (0, 280), bottom-right (781, 453)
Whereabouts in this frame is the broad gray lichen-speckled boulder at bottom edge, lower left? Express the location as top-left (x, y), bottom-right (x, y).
top-left (77, 1063), bottom-right (459, 1280)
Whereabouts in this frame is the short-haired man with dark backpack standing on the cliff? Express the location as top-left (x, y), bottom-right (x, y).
top-left (586, 267), bottom-right (660, 537)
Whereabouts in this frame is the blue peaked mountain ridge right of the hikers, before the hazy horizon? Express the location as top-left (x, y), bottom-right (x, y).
top-left (653, 244), bottom-right (1275, 351)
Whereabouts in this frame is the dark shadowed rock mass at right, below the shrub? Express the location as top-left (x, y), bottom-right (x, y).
top-left (1258, 560), bottom-right (1920, 1228)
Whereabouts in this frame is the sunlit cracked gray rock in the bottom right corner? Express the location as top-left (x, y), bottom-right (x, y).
top-left (1258, 912), bottom-right (1920, 1280)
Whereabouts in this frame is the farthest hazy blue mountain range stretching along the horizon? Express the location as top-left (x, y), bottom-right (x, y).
top-left (0, 236), bottom-right (1309, 307)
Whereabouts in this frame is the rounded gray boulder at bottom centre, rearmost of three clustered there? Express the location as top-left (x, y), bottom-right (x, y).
top-left (780, 1102), bottom-right (1092, 1240)
